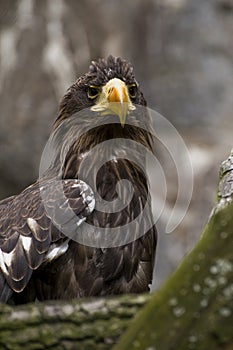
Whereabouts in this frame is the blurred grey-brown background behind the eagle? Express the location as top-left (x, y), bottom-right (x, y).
top-left (0, 0), bottom-right (233, 288)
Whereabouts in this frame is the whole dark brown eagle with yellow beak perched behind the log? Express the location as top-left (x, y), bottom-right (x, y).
top-left (0, 55), bottom-right (157, 305)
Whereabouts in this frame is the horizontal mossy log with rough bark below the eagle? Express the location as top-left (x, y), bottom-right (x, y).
top-left (0, 295), bottom-right (150, 350)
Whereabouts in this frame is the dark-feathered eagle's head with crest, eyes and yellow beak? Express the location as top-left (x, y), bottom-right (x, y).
top-left (55, 56), bottom-right (146, 127)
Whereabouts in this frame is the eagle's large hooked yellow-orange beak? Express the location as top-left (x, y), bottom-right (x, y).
top-left (92, 78), bottom-right (135, 127)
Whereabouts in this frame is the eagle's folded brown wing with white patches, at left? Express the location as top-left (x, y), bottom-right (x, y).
top-left (0, 179), bottom-right (95, 302)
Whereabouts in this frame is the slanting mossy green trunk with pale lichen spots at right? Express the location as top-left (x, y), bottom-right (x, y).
top-left (114, 152), bottom-right (233, 350)
